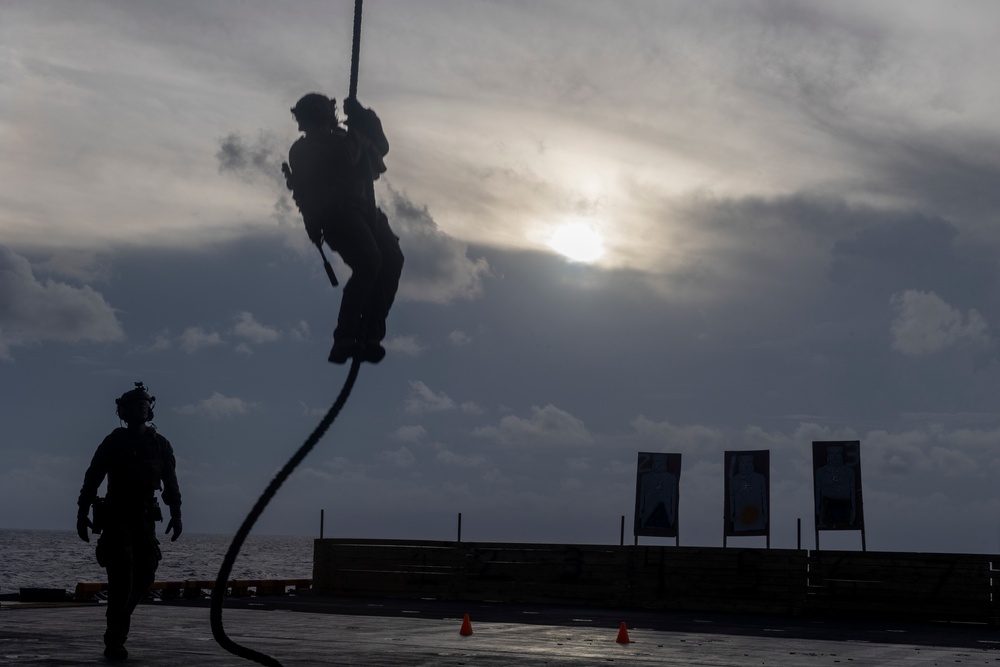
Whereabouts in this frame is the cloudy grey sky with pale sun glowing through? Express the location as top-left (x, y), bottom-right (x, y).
top-left (0, 0), bottom-right (1000, 553)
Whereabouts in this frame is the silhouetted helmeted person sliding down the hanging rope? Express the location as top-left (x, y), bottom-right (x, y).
top-left (282, 93), bottom-right (403, 364)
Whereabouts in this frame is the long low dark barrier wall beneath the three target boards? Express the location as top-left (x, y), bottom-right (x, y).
top-left (313, 539), bottom-right (1000, 623)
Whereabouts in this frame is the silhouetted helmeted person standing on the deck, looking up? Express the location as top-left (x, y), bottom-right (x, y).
top-left (76, 382), bottom-right (183, 660)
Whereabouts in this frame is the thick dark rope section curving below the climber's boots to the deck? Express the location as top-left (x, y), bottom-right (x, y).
top-left (211, 356), bottom-right (361, 667)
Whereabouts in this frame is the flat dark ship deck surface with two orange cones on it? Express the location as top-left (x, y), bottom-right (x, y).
top-left (0, 596), bottom-right (1000, 667)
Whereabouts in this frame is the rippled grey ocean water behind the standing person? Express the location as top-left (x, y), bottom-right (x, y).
top-left (0, 530), bottom-right (314, 595)
